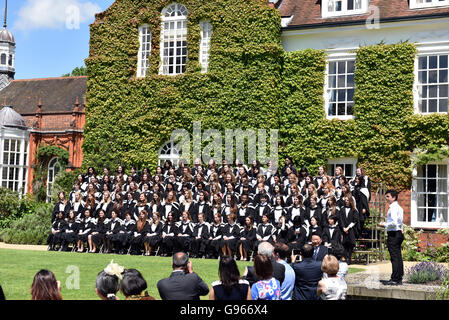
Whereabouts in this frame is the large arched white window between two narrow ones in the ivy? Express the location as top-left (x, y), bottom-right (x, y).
top-left (159, 3), bottom-right (188, 75)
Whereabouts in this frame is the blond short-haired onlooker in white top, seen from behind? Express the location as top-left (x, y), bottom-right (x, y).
top-left (317, 255), bottom-right (348, 300)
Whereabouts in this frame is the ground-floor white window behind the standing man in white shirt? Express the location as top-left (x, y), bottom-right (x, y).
top-left (411, 160), bottom-right (449, 228)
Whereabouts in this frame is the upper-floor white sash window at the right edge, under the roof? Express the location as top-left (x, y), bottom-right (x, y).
top-left (415, 51), bottom-right (449, 114)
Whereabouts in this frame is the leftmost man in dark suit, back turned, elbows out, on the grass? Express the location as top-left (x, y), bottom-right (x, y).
top-left (157, 252), bottom-right (209, 300)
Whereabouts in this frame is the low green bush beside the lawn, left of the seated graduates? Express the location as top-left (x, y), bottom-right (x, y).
top-left (0, 203), bottom-right (53, 245)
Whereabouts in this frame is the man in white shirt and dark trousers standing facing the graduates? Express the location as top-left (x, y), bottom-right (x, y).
top-left (379, 190), bottom-right (404, 285)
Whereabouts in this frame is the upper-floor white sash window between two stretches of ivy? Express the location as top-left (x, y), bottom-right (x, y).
top-left (324, 54), bottom-right (355, 120)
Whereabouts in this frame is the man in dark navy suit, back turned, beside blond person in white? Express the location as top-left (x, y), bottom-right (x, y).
top-left (292, 244), bottom-right (323, 300)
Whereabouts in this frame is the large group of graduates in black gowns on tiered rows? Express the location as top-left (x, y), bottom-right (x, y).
top-left (48, 157), bottom-right (370, 263)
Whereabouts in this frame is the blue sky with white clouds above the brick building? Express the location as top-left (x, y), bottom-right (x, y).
top-left (7, 0), bottom-right (114, 79)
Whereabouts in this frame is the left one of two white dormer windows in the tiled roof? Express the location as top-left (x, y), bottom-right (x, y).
top-left (321, 0), bottom-right (369, 18)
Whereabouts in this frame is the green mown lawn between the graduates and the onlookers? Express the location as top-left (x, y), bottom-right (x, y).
top-left (0, 249), bottom-right (363, 300)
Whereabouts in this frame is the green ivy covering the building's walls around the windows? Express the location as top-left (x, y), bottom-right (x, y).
top-left (83, 0), bottom-right (449, 189)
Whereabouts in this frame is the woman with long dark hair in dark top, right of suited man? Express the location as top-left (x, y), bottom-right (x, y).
top-left (209, 256), bottom-right (251, 301)
